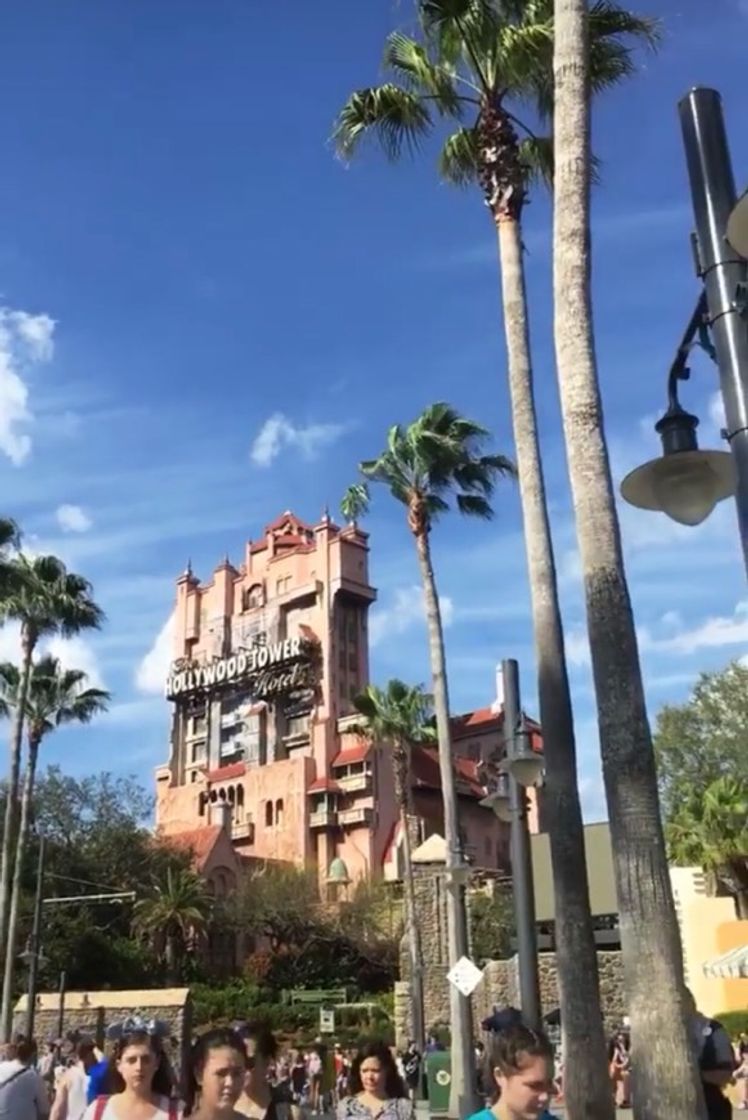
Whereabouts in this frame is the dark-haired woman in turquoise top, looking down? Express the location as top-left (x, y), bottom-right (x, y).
top-left (469, 1023), bottom-right (553, 1120)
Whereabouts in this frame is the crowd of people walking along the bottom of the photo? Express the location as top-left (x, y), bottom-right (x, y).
top-left (0, 1007), bottom-right (748, 1120)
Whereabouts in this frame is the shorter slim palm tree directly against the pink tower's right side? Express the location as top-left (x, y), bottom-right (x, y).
top-left (351, 676), bottom-right (436, 1054)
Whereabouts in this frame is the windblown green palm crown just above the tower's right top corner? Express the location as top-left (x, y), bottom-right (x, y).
top-left (343, 402), bottom-right (514, 536)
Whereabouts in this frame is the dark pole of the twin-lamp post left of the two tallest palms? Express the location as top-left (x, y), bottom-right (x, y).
top-left (502, 660), bottom-right (541, 1030)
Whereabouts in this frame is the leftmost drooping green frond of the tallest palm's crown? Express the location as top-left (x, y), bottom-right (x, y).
top-left (333, 82), bottom-right (432, 160)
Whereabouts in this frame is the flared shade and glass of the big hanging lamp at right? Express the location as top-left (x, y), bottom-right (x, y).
top-left (620, 449), bottom-right (736, 525)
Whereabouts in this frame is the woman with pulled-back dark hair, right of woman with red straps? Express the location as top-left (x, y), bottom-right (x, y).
top-left (185, 1029), bottom-right (246, 1120)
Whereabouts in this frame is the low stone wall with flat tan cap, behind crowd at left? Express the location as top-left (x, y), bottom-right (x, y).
top-left (13, 988), bottom-right (193, 1072)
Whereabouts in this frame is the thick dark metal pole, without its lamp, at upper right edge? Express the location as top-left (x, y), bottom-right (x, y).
top-left (679, 87), bottom-right (748, 570)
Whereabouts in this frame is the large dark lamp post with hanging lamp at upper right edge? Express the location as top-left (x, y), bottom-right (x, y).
top-left (620, 87), bottom-right (748, 569)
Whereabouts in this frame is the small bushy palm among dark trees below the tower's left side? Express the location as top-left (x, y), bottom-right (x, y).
top-left (133, 867), bottom-right (212, 983)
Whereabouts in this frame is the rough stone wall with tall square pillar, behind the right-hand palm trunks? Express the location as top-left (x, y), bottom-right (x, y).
top-left (394, 867), bottom-right (626, 1046)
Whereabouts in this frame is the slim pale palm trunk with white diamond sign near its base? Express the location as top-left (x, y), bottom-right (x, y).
top-left (414, 529), bottom-right (475, 1118)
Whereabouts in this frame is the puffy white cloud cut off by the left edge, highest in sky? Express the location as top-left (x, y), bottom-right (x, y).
top-left (0, 307), bottom-right (55, 467)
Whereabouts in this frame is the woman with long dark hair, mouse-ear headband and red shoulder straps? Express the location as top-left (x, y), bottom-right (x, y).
top-left (83, 1017), bottom-right (181, 1120)
